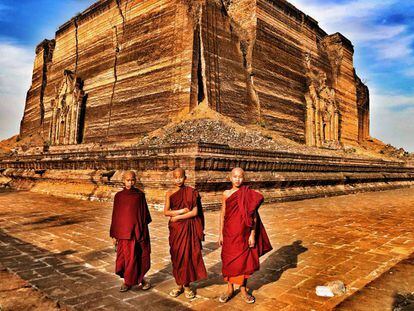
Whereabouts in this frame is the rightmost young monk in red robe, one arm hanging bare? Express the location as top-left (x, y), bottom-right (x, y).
top-left (219, 168), bottom-right (272, 303)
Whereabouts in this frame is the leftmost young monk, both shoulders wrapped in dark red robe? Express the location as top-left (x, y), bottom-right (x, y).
top-left (110, 171), bottom-right (151, 292)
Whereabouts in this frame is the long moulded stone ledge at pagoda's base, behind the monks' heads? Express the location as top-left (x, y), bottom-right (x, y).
top-left (0, 143), bottom-right (414, 209)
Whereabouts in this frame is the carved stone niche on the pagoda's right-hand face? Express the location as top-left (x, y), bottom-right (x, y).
top-left (305, 56), bottom-right (340, 148)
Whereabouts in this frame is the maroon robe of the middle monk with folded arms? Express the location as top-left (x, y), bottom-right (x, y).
top-left (168, 186), bottom-right (207, 285)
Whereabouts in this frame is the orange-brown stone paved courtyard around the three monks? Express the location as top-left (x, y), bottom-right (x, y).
top-left (0, 188), bottom-right (414, 310)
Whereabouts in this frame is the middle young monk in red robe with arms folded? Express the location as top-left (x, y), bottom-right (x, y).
top-left (164, 168), bottom-right (207, 299)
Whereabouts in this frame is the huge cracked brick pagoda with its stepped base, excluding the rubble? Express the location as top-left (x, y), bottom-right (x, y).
top-left (0, 0), bottom-right (414, 210)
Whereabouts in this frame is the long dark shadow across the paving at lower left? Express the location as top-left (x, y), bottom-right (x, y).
top-left (0, 229), bottom-right (189, 310)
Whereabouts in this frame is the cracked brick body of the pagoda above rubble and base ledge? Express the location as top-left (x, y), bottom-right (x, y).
top-left (20, 0), bottom-right (369, 146)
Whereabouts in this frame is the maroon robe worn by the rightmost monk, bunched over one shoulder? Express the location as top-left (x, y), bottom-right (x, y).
top-left (221, 186), bottom-right (272, 277)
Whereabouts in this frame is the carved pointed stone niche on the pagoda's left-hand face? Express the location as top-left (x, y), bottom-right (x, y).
top-left (49, 70), bottom-right (86, 145)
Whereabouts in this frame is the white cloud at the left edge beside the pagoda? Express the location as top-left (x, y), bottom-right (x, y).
top-left (0, 42), bottom-right (34, 140)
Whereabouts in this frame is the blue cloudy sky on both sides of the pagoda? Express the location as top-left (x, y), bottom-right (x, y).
top-left (0, 0), bottom-right (414, 152)
